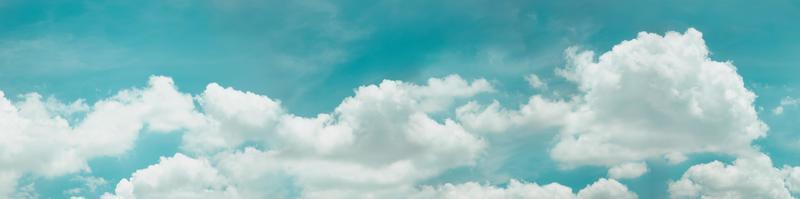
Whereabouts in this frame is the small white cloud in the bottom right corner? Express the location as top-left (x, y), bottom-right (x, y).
top-left (669, 154), bottom-right (800, 199)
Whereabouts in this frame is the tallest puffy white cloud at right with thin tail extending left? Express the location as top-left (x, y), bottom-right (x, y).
top-left (458, 29), bottom-right (767, 178)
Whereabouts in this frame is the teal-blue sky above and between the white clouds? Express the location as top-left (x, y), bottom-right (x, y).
top-left (0, 0), bottom-right (800, 198)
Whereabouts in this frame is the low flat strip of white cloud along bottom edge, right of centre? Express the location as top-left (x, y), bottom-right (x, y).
top-left (411, 179), bottom-right (637, 199)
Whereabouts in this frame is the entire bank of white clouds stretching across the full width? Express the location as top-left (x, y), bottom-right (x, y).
top-left (0, 29), bottom-right (800, 199)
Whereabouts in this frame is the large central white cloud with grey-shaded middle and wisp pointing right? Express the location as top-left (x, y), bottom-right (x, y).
top-left (214, 76), bottom-right (492, 198)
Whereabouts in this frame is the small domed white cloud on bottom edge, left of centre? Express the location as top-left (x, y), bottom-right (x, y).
top-left (102, 153), bottom-right (239, 199)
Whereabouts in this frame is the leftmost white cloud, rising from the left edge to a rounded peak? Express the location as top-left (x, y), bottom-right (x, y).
top-left (0, 76), bottom-right (200, 195)
